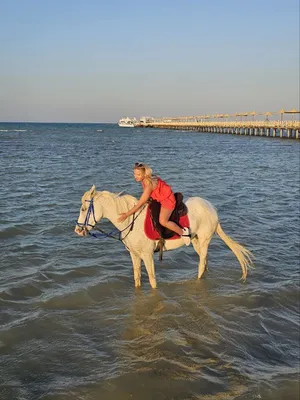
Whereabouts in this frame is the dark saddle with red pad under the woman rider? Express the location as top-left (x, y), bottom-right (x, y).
top-left (149, 192), bottom-right (189, 239)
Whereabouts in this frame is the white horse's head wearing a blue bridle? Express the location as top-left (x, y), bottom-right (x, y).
top-left (75, 185), bottom-right (101, 236)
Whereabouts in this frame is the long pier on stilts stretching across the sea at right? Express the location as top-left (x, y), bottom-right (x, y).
top-left (137, 109), bottom-right (300, 139)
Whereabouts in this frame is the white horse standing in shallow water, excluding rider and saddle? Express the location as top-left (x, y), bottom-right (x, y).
top-left (75, 185), bottom-right (253, 288)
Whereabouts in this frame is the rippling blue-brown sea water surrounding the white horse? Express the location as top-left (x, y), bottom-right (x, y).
top-left (0, 124), bottom-right (300, 400)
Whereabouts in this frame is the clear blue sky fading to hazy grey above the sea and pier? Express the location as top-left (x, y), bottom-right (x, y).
top-left (0, 0), bottom-right (299, 122)
